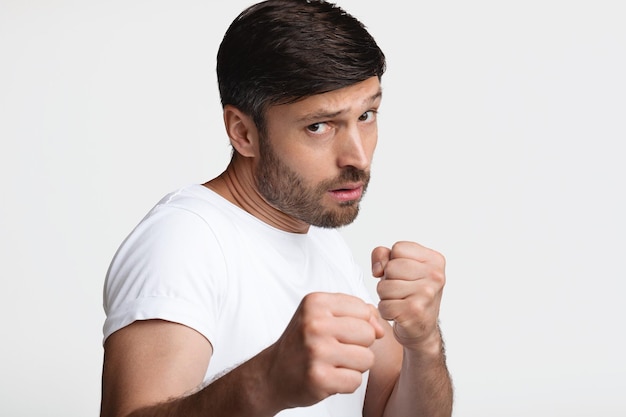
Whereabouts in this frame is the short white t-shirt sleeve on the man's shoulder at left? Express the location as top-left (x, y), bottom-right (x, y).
top-left (103, 206), bottom-right (226, 341)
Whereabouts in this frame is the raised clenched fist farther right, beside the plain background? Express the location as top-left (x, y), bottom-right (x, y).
top-left (372, 242), bottom-right (445, 350)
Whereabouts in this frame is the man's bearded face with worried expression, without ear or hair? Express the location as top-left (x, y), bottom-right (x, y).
top-left (256, 77), bottom-right (381, 227)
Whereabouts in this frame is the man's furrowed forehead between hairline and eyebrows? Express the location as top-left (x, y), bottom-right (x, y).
top-left (267, 77), bottom-right (382, 122)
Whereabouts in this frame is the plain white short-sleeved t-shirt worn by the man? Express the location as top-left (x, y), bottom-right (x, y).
top-left (104, 185), bottom-right (371, 417)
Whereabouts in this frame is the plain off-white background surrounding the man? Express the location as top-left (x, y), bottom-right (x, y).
top-left (0, 0), bottom-right (626, 417)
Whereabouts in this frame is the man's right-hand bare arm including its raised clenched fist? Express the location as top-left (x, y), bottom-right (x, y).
top-left (364, 242), bottom-right (452, 417)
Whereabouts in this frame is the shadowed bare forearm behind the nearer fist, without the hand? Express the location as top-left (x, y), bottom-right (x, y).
top-left (128, 351), bottom-right (281, 417)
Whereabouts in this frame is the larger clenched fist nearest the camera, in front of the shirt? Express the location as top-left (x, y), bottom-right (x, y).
top-left (268, 293), bottom-right (385, 407)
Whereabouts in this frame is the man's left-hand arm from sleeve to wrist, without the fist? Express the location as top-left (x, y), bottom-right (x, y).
top-left (101, 320), bottom-right (282, 417)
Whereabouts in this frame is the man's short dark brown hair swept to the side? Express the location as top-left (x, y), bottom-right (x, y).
top-left (217, 0), bottom-right (385, 129)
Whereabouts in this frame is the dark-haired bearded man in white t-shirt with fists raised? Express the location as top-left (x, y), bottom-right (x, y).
top-left (101, 0), bottom-right (452, 417)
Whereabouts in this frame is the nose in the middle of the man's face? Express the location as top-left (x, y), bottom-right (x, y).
top-left (337, 126), bottom-right (376, 170)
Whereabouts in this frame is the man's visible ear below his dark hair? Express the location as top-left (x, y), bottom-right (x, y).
top-left (224, 104), bottom-right (259, 157)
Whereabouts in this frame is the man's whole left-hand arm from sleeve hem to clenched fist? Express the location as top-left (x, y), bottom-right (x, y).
top-left (101, 293), bottom-right (384, 417)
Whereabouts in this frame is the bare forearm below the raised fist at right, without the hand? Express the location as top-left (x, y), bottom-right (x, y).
top-left (384, 336), bottom-right (453, 417)
